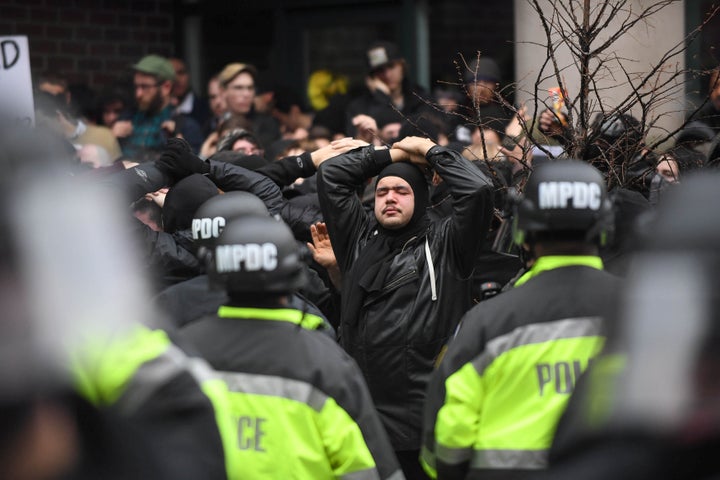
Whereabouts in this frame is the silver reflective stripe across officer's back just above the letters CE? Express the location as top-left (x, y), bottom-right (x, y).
top-left (218, 372), bottom-right (328, 412)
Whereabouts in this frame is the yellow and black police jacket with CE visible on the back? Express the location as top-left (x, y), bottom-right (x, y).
top-left (180, 306), bottom-right (403, 480)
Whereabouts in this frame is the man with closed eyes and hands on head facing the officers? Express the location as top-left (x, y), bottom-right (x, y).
top-left (318, 137), bottom-right (493, 478)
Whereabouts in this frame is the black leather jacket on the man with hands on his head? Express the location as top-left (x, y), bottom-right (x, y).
top-left (318, 146), bottom-right (493, 451)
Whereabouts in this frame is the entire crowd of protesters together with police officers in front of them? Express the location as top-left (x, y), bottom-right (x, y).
top-left (0, 41), bottom-right (720, 480)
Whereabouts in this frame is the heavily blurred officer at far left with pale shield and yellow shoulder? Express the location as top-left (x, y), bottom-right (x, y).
top-left (0, 130), bottom-right (225, 480)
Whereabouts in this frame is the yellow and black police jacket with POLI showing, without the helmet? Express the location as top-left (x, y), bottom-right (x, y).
top-left (421, 256), bottom-right (620, 478)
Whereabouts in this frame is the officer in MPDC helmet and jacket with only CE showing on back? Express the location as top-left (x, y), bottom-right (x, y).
top-left (176, 217), bottom-right (404, 480)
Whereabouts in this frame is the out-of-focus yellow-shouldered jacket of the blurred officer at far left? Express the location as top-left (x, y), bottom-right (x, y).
top-left (72, 324), bottom-right (228, 479)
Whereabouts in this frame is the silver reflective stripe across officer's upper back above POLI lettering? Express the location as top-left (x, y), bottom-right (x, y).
top-left (472, 317), bottom-right (602, 375)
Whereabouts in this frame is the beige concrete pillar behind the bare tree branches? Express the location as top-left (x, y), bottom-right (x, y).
top-left (514, 0), bottom-right (685, 146)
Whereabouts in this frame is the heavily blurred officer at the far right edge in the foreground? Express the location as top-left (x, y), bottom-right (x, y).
top-left (533, 171), bottom-right (720, 480)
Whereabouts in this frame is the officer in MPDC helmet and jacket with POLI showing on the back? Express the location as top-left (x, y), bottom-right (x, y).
top-left (421, 160), bottom-right (619, 479)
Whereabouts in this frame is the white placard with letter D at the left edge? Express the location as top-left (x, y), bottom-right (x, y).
top-left (0, 36), bottom-right (35, 127)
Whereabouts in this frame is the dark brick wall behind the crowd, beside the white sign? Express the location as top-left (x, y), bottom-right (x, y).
top-left (0, 0), bottom-right (174, 89)
